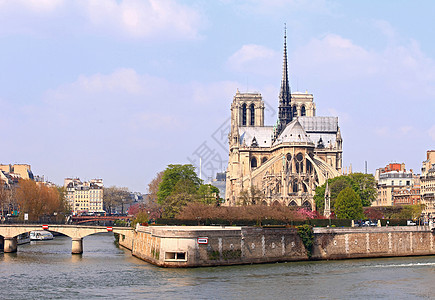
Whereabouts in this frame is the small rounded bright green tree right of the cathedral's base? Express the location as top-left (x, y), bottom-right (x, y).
top-left (335, 187), bottom-right (364, 220)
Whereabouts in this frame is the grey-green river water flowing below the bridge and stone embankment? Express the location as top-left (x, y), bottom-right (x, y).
top-left (0, 233), bottom-right (435, 300)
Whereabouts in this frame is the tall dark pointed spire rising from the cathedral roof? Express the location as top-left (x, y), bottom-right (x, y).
top-left (275, 24), bottom-right (293, 139)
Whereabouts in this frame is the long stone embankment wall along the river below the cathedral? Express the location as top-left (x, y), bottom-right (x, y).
top-left (119, 226), bottom-right (435, 268)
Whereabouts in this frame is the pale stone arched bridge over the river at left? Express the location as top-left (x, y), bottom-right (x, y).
top-left (0, 224), bottom-right (133, 254)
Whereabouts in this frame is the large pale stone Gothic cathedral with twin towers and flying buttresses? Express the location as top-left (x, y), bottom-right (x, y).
top-left (225, 30), bottom-right (343, 210)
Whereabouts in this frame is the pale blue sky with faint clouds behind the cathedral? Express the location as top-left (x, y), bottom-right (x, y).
top-left (0, 0), bottom-right (435, 192)
